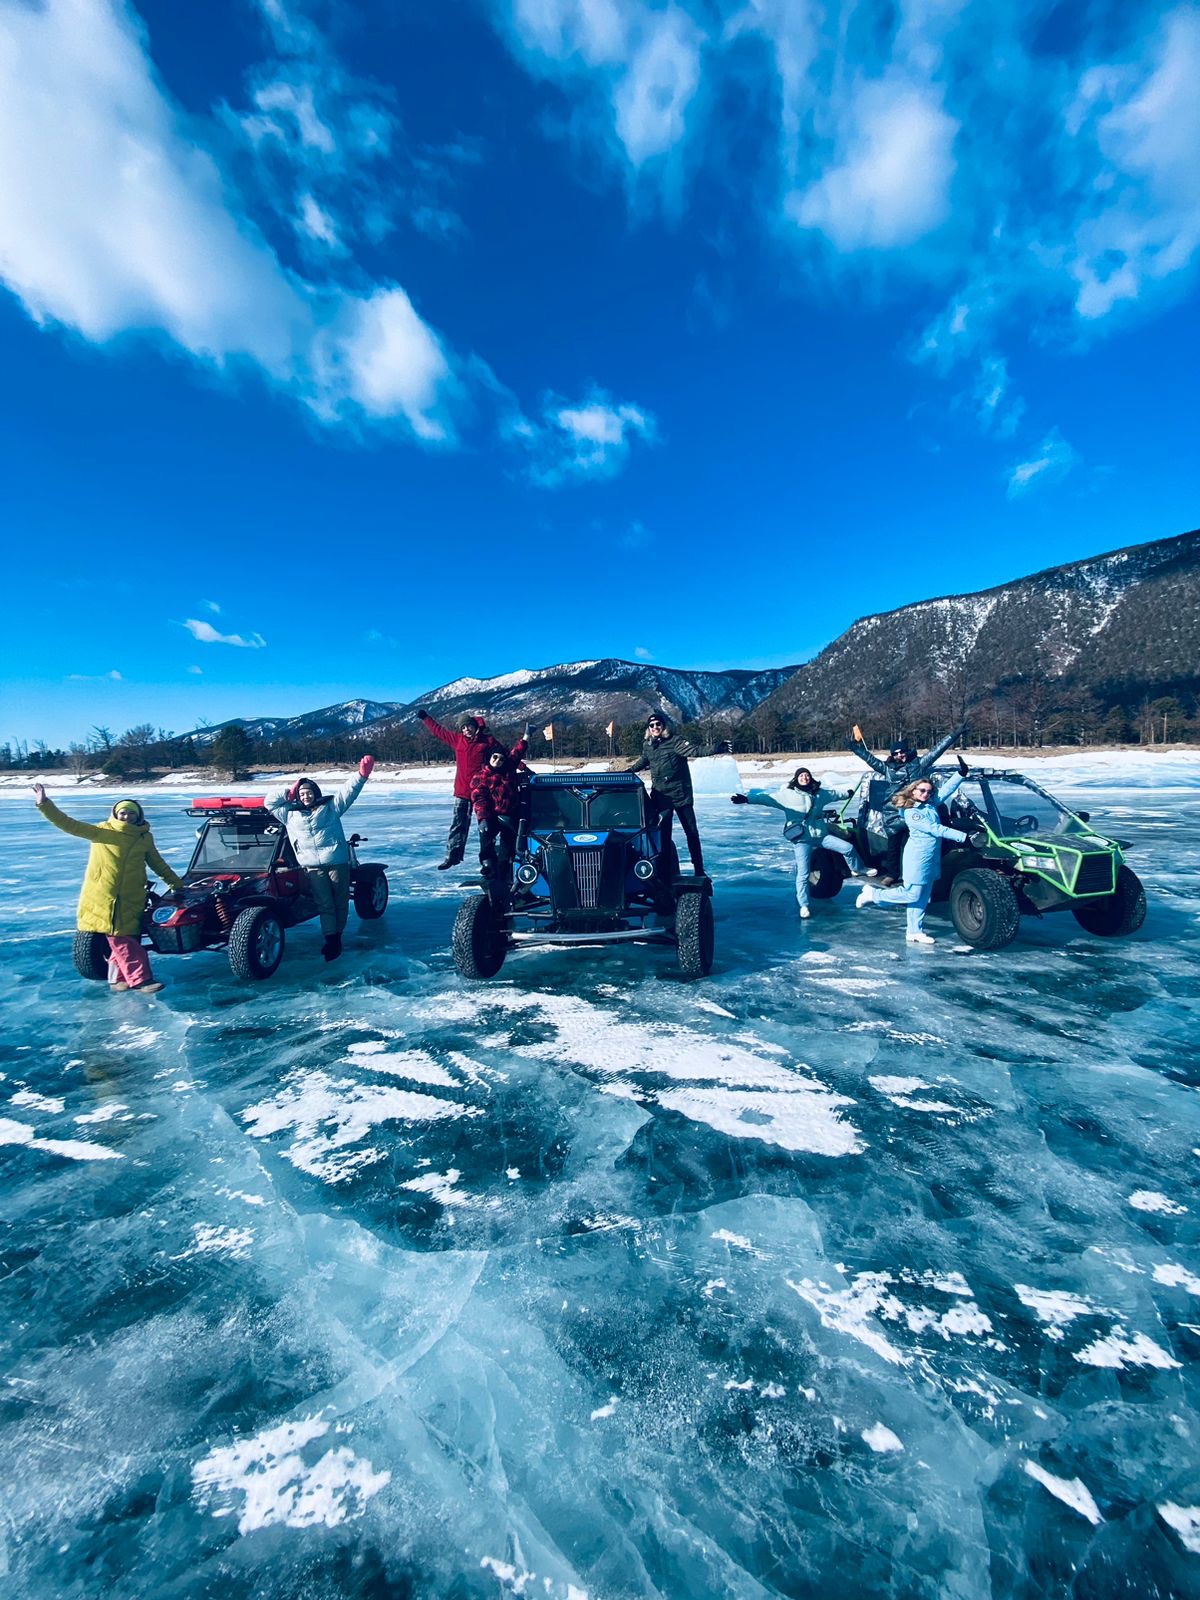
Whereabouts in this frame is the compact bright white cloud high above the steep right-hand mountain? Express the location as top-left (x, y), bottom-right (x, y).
top-left (787, 80), bottom-right (958, 251)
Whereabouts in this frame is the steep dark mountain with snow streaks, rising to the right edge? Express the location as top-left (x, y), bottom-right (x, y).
top-left (766, 530), bottom-right (1200, 720)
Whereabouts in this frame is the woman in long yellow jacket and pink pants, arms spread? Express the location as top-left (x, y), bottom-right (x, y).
top-left (34, 784), bottom-right (184, 994)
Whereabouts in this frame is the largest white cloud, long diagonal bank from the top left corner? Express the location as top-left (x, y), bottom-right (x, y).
top-left (0, 0), bottom-right (456, 442)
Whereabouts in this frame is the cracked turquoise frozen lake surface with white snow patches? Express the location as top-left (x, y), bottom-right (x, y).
top-left (0, 760), bottom-right (1200, 1600)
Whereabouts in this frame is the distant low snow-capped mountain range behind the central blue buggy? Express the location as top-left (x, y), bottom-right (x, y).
top-left (189, 658), bottom-right (795, 744)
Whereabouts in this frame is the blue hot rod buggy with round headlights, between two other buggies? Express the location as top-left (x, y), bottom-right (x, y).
top-left (453, 773), bottom-right (712, 978)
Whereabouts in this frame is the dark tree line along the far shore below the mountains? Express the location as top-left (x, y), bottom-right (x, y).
top-left (0, 678), bottom-right (1200, 781)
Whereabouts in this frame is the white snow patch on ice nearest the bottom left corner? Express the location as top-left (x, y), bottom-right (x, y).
top-left (192, 1416), bottom-right (392, 1534)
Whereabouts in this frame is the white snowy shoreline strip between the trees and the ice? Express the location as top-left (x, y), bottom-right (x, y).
top-left (9, 746), bottom-right (1200, 798)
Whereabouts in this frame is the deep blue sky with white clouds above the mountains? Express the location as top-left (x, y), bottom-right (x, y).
top-left (0, 0), bottom-right (1200, 744)
